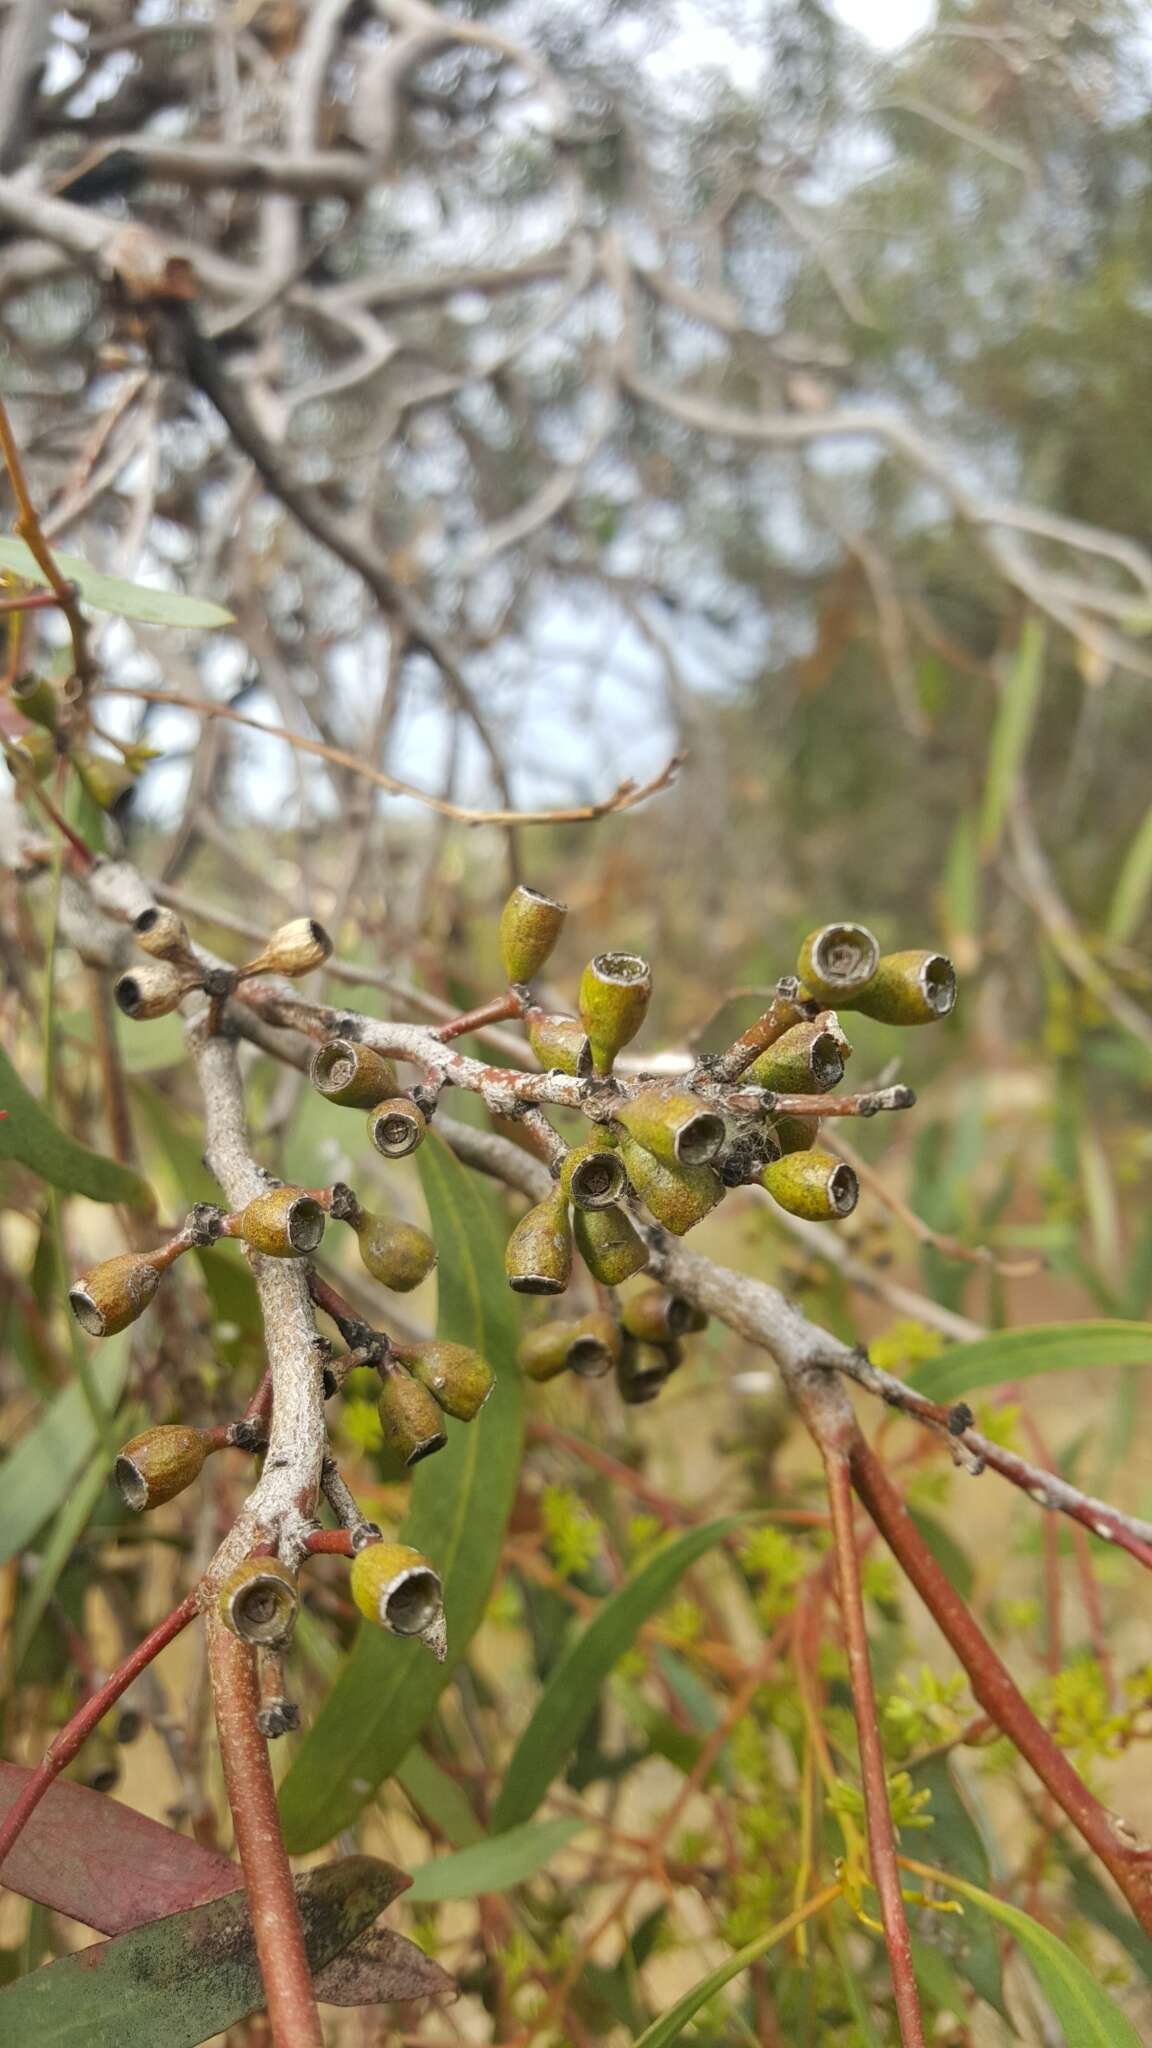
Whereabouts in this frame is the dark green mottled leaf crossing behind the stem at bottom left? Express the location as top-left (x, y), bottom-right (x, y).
top-left (0, 1855), bottom-right (404, 2048)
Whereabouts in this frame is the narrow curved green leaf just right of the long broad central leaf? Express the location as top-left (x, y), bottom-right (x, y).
top-left (492, 1516), bottom-right (742, 1835)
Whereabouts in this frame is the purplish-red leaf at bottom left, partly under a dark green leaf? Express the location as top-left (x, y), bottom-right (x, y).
top-left (0, 1763), bottom-right (455, 2005)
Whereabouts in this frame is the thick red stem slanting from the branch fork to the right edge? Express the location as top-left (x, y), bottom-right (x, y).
top-left (849, 1434), bottom-right (1152, 1933)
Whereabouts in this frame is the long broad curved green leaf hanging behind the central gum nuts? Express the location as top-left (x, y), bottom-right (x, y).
top-left (281, 1139), bottom-right (527, 1853)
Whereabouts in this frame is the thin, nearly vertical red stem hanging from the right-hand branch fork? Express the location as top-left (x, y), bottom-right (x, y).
top-left (824, 1450), bottom-right (924, 2048)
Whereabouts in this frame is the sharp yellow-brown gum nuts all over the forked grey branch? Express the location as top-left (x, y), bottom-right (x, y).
top-left (58, 887), bottom-right (955, 1679)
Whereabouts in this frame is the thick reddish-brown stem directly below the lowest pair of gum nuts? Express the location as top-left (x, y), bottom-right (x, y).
top-left (207, 1614), bottom-right (324, 2048)
